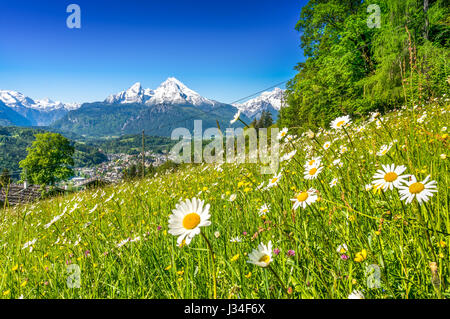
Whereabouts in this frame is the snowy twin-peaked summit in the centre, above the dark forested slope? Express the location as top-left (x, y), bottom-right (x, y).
top-left (105, 77), bottom-right (220, 107)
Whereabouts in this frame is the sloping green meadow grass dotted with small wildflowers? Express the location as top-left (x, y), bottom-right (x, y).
top-left (0, 100), bottom-right (450, 298)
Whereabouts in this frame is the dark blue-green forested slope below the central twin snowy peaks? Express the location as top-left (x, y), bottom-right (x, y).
top-left (52, 102), bottom-right (250, 138)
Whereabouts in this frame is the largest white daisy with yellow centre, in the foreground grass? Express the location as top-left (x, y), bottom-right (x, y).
top-left (169, 197), bottom-right (211, 245)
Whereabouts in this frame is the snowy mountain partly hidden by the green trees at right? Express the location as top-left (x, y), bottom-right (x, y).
top-left (233, 88), bottom-right (284, 119)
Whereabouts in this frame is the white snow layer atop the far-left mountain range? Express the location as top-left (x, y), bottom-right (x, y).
top-left (0, 90), bottom-right (80, 112)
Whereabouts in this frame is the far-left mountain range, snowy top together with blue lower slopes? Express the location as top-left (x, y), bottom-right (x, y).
top-left (0, 90), bottom-right (80, 126)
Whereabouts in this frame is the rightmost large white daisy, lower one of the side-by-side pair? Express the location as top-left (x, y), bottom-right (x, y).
top-left (398, 175), bottom-right (437, 204)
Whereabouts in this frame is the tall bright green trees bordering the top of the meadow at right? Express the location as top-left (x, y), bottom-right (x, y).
top-left (279, 0), bottom-right (450, 128)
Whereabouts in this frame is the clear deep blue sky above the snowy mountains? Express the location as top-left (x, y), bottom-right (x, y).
top-left (0, 0), bottom-right (306, 102)
